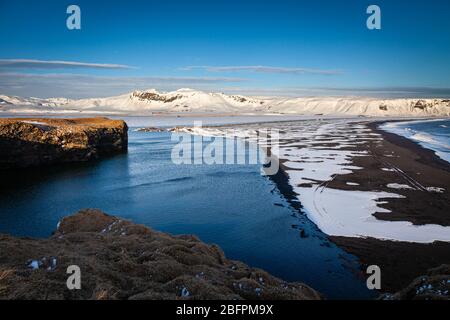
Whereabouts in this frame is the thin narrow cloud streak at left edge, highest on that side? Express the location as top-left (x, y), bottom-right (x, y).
top-left (0, 59), bottom-right (136, 69)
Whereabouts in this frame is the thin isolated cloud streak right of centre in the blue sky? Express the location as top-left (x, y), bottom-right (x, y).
top-left (180, 66), bottom-right (342, 75)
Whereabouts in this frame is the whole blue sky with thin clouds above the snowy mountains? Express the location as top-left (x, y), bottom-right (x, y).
top-left (0, 0), bottom-right (450, 98)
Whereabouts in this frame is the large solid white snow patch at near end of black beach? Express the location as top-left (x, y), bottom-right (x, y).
top-left (294, 188), bottom-right (450, 243)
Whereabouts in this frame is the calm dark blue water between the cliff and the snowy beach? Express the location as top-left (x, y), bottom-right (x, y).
top-left (0, 131), bottom-right (373, 298)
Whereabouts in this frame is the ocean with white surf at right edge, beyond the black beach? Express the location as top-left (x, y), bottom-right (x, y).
top-left (381, 119), bottom-right (450, 162)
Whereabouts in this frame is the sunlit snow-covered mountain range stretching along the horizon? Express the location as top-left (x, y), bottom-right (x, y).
top-left (0, 89), bottom-right (450, 116)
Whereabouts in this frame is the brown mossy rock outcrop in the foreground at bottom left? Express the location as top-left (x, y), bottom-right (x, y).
top-left (0, 209), bottom-right (321, 299)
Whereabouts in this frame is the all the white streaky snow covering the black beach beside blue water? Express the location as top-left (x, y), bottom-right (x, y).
top-left (179, 119), bottom-right (450, 243)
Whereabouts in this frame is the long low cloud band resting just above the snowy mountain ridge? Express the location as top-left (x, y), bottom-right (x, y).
top-left (0, 72), bottom-right (450, 98)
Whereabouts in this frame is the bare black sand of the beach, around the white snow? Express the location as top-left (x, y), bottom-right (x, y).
top-left (324, 122), bottom-right (450, 291)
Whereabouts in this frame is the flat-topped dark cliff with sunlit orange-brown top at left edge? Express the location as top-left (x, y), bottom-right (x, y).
top-left (0, 118), bottom-right (128, 169)
